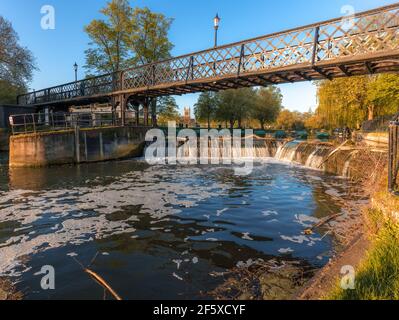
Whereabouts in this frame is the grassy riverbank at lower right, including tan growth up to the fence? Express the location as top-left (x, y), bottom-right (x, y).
top-left (327, 184), bottom-right (399, 300)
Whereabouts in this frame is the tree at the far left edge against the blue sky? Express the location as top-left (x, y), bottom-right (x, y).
top-left (0, 16), bottom-right (36, 103)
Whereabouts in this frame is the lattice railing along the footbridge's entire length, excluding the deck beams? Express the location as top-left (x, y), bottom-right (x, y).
top-left (18, 3), bottom-right (399, 104)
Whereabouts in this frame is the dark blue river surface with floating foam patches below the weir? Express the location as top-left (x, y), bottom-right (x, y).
top-left (0, 160), bottom-right (362, 299)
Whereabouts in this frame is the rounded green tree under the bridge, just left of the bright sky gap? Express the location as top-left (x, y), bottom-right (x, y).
top-left (251, 86), bottom-right (283, 129)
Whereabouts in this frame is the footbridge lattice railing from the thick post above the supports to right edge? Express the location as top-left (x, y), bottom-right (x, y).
top-left (122, 4), bottom-right (399, 90)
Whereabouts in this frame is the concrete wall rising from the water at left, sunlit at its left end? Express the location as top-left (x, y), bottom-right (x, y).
top-left (9, 127), bottom-right (148, 167)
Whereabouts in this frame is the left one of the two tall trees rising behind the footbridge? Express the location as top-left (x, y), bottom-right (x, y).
top-left (85, 0), bottom-right (133, 74)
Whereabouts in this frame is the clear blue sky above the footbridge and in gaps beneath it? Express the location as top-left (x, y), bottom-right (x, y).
top-left (0, 0), bottom-right (396, 111)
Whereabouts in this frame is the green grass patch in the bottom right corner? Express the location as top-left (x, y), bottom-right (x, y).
top-left (328, 209), bottom-right (399, 300)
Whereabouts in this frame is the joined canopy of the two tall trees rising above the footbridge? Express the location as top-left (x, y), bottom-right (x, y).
top-left (85, 0), bottom-right (173, 74)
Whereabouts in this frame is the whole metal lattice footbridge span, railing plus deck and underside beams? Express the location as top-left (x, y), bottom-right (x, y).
top-left (18, 3), bottom-right (399, 105)
